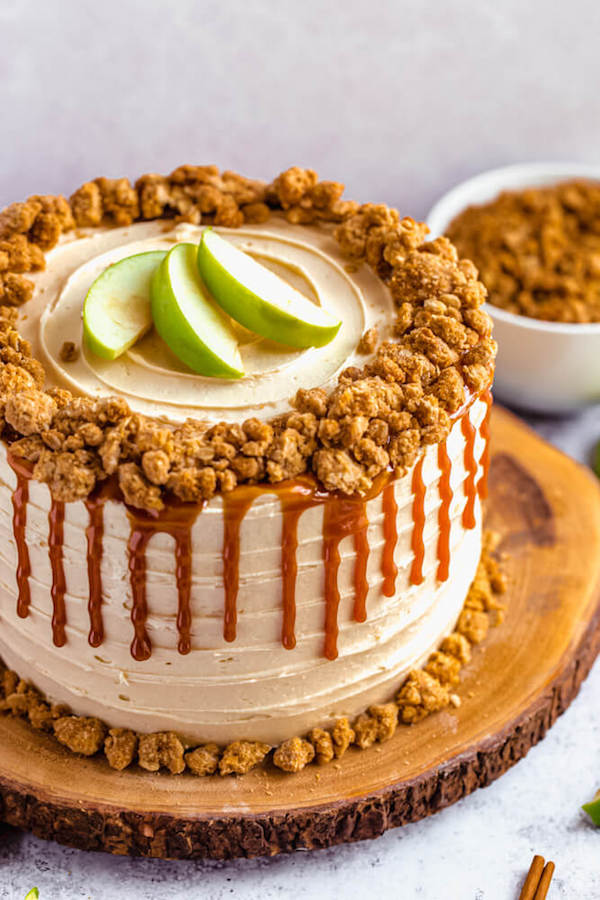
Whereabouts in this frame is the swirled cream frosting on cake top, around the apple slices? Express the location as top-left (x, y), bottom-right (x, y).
top-left (22, 216), bottom-right (393, 422)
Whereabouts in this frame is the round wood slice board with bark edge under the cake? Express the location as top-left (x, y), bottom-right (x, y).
top-left (0, 409), bottom-right (600, 859)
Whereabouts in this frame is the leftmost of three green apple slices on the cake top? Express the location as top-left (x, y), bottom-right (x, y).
top-left (83, 250), bottom-right (166, 359)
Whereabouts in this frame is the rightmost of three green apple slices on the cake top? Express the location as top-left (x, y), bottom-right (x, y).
top-left (198, 229), bottom-right (342, 348)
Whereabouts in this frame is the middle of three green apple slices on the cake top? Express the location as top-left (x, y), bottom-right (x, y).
top-left (150, 244), bottom-right (244, 378)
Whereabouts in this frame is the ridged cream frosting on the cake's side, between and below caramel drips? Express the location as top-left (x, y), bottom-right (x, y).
top-left (0, 400), bottom-right (487, 743)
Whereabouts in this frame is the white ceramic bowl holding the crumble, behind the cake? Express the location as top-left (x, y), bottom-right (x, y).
top-left (427, 163), bottom-right (600, 414)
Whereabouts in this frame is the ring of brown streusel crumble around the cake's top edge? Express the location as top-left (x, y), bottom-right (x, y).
top-left (0, 166), bottom-right (496, 510)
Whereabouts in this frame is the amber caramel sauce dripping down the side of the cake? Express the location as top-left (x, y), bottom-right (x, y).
top-left (8, 391), bottom-right (492, 661)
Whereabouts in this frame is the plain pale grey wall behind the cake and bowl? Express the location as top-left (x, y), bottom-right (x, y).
top-left (0, 0), bottom-right (600, 215)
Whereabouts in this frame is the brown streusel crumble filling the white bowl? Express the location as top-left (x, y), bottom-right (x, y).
top-left (448, 181), bottom-right (600, 322)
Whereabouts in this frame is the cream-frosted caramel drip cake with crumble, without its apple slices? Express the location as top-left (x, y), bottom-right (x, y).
top-left (0, 166), bottom-right (495, 774)
